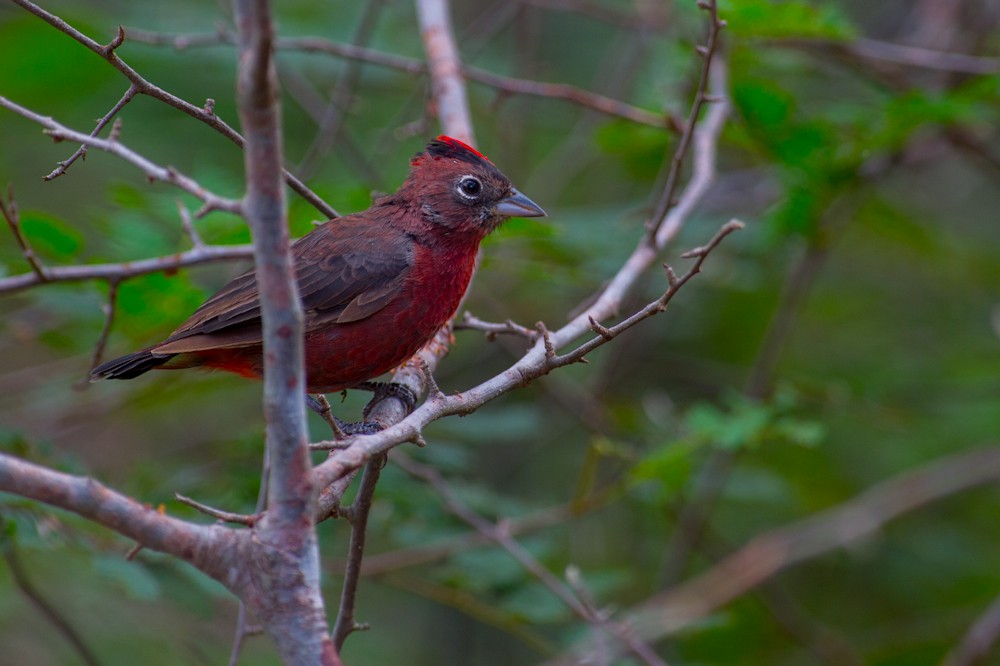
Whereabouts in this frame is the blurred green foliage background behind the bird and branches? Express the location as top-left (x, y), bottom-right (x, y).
top-left (0, 0), bottom-right (1000, 666)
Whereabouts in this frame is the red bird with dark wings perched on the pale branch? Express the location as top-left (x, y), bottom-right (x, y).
top-left (91, 135), bottom-right (545, 420)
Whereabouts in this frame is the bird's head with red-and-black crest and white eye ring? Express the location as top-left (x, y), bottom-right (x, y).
top-left (398, 135), bottom-right (545, 236)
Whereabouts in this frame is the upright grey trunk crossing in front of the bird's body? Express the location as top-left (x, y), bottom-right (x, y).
top-left (235, 0), bottom-right (339, 664)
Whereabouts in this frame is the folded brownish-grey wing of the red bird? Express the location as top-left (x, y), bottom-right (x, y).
top-left (153, 215), bottom-right (413, 354)
